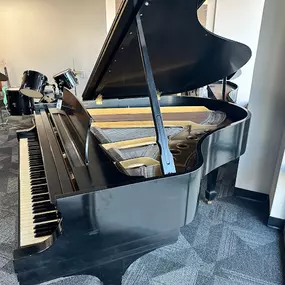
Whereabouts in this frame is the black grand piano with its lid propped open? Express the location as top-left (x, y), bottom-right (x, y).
top-left (14, 0), bottom-right (251, 285)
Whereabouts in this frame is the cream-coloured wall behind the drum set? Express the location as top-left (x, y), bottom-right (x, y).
top-left (0, 0), bottom-right (106, 95)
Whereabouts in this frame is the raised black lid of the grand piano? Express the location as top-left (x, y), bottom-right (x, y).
top-left (83, 0), bottom-right (251, 100)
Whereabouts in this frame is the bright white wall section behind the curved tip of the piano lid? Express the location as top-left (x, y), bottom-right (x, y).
top-left (214, 0), bottom-right (266, 105)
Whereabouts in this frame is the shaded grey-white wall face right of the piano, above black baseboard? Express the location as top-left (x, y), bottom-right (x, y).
top-left (236, 0), bottom-right (285, 200)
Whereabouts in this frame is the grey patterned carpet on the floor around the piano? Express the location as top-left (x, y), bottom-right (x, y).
top-left (0, 118), bottom-right (283, 285)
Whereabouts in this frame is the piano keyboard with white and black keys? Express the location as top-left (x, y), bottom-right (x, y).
top-left (19, 137), bottom-right (60, 247)
